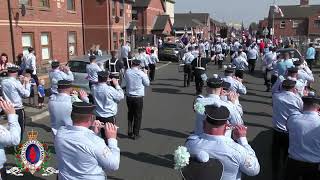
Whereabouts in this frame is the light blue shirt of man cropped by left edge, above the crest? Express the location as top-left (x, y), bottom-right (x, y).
top-left (0, 114), bottom-right (21, 168)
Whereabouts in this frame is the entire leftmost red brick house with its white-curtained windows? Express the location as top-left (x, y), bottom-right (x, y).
top-left (0, 0), bottom-right (83, 68)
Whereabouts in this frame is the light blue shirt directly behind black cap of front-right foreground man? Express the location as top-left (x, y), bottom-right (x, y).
top-left (194, 94), bottom-right (243, 134)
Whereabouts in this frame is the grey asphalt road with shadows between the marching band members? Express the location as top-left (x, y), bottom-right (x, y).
top-left (7, 58), bottom-right (320, 180)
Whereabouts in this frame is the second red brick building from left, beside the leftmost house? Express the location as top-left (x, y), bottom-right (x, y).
top-left (83, 0), bottom-right (134, 52)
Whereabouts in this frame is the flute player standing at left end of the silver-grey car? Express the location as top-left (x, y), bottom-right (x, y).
top-left (49, 61), bottom-right (74, 94)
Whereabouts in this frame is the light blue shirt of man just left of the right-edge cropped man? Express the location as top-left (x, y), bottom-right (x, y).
top-left (272, 91), bottom-right (303, 132)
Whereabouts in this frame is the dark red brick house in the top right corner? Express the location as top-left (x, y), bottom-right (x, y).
top-left (268, 0), bottom-right (320, 39)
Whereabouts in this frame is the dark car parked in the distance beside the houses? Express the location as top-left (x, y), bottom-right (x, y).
top-left (158, 43), bottom-right (185, 62)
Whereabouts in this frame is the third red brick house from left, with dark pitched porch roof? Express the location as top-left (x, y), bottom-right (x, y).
top-left (132, 0), bottom-right (175, 45)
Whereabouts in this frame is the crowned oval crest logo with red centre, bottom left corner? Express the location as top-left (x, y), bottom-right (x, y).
top-left (7, 130), bottom-right (58, 176)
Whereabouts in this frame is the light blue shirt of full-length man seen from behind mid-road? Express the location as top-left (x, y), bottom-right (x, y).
top-left (124, 67), bottom-right (150, 97)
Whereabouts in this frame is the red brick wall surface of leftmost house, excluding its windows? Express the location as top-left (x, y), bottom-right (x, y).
top-left (0, 0), bottom-right (83, 67)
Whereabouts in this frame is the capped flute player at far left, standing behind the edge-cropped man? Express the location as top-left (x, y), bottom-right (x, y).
top-left (1, 67), bottom-right (31, 141)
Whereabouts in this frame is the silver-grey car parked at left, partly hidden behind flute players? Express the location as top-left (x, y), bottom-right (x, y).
top-left (68, 54), bottom-right (111, 93)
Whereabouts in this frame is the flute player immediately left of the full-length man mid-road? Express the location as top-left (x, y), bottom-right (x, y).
top-left (92, 71), bottom-right (124, 139)
